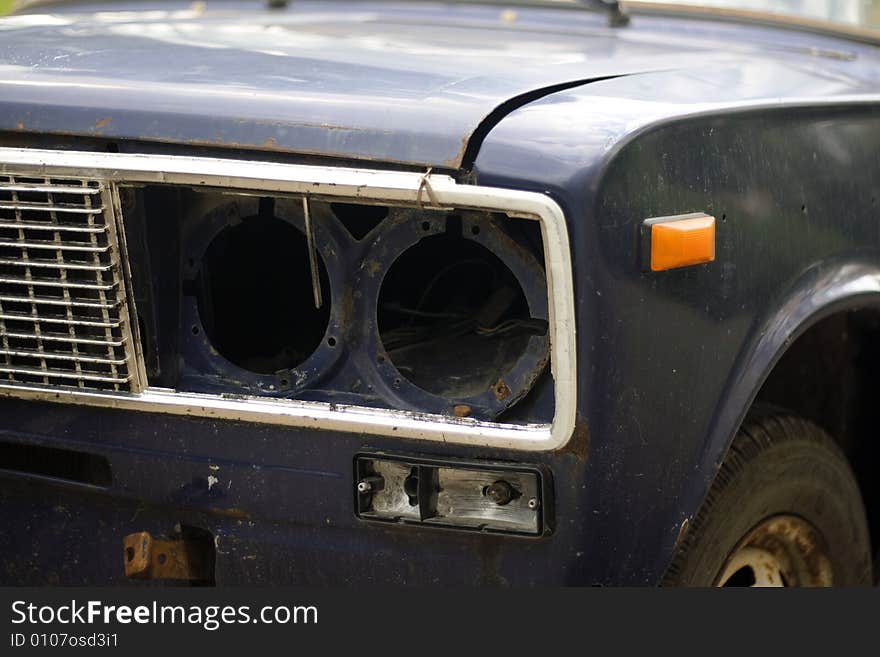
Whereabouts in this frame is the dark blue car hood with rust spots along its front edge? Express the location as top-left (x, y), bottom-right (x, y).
top-left (0, 1), bottom-right (868, 169)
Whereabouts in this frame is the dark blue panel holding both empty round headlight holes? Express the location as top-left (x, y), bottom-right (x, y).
top-left (166, 188), bottom-right (554, 424)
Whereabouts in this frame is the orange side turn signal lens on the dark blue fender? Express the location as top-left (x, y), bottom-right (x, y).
top-left (645, 212), bottom-right (715, 271)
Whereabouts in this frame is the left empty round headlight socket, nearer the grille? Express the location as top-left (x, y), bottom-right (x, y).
top-left (179, 191), bottom-right (346, 397)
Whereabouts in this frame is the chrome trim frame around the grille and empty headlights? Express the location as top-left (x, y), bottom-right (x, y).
top-left (0, 148), bottom-right (577, 451)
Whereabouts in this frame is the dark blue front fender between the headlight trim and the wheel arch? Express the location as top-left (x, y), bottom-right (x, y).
top-left (477, 93), bottom-right (880, 582)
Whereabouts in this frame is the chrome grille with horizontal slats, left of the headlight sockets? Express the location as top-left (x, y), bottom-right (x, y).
top-left (0, 175), bottom-right (136, 392)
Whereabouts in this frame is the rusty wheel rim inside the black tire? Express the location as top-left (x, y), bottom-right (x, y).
top-left (715, 515), bottom-right (832, 587)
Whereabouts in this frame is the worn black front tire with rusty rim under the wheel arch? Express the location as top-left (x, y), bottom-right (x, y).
top-left (663, 409), bottom-right (871, 586)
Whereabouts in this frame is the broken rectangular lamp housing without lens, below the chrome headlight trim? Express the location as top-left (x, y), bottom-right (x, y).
top-left (354, 454), bottom-right (553, 536)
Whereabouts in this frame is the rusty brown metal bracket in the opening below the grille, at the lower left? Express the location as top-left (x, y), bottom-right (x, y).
top-left (122, 532), bottom-right (213, 581)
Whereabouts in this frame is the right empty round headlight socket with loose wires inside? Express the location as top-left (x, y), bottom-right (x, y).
top-left (355, 211), bottom-right (550, 419)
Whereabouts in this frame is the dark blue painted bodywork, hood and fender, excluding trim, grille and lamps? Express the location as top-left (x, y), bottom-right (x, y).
top-left (0, 3), bottom-right (880, 584)
